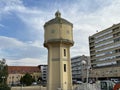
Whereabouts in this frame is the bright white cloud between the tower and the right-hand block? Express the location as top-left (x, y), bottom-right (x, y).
top-left (65, 0), bottom-right (120, 56)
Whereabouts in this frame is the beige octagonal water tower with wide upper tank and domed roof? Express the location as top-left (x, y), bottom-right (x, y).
top-left (44, 11), bottom-right (74, 90)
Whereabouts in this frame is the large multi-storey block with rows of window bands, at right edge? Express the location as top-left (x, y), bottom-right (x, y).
top-left (89, 23), bottom-right (120, 79)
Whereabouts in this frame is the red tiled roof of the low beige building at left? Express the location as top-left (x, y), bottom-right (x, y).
top-left (8, 66), bottom-right (40, 74)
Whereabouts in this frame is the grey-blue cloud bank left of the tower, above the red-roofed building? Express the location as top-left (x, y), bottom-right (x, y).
top-left (0, 36), bottom-right (46, 60)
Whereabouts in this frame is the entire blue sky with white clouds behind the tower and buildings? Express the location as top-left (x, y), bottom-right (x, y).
top-left (0, 0), bottom-right (120, 66)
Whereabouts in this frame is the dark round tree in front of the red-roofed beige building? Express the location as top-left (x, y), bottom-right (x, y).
top-left (20, 73), bottom-right (35, 86)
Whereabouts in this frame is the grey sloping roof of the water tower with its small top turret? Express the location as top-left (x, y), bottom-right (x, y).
top-left (44, 11), bottom-right (73, 27)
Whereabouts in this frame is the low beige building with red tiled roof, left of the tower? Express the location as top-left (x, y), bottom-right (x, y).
top-left (7, 66), bottom-right (41, 85)
